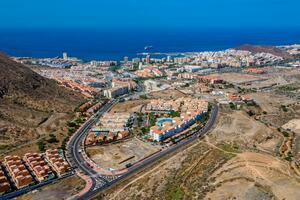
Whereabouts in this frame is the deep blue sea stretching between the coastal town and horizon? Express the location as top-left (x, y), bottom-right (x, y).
top-left (0, 28), bottom-right (300, 60)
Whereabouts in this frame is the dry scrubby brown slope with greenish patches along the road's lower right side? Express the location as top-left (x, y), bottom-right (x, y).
top-left (99, 141), bottom-right (232, 199)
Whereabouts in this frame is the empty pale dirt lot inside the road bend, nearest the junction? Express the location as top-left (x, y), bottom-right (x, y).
top-left (86, 138), bottom-right (159, 169)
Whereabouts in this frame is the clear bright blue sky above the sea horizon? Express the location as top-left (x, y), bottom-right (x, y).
top-left (0, 0), bottom-right (300, 29)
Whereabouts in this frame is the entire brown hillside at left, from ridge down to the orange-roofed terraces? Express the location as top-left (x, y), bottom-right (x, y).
top-left (0, 54), bottom-right (83, 153)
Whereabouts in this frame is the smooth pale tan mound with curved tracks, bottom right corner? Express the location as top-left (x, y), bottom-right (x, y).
top-left (206, 152), bottom-right (300, 200)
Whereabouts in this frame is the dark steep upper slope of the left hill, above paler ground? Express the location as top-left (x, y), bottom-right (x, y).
top-left (0, 54), bottom-right (82, 112)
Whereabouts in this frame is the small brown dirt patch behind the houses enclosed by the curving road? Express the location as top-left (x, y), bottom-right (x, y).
top-left (110, 100), bottom-right (149, 113)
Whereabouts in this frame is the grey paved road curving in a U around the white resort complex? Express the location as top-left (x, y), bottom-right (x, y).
top-left (68, 104), bottom-right (218, 199)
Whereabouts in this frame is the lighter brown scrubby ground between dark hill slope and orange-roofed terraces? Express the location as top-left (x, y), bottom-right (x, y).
top-left (0, 110), bottom-right (74, 158)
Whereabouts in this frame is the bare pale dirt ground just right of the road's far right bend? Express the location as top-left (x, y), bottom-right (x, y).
top-left (211, 111), bottom-right (282, 153)
